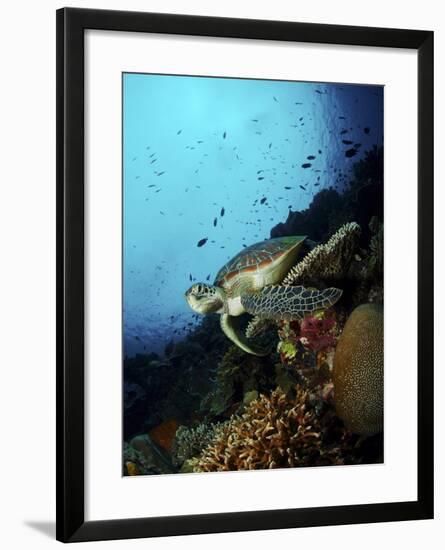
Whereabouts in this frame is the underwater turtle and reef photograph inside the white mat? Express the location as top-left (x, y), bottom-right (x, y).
top-left (122, 73), bottom-right (384, 476)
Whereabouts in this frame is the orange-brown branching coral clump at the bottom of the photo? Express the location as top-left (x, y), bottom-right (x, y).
top-left (193, 386), bottom-right (341, 472)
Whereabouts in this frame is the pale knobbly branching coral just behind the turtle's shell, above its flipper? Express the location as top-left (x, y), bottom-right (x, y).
top-left (282, 222), bottom-right (361, 285)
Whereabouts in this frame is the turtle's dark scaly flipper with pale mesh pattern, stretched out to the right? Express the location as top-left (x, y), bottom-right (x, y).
top-left (241, 285), bottom-right (342, 321)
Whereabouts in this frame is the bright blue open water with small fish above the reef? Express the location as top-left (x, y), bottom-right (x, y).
top-left (123, 73), bottom-right (383, 357)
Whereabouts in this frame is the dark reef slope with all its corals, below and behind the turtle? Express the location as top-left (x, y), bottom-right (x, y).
top-left (123, 148), bottom-right (383, 475)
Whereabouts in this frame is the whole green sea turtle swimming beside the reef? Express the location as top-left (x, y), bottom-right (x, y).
top-left (185, 237), bottom-right (342, 355)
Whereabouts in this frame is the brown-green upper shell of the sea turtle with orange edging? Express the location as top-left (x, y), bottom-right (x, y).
top-left (214, 236), bottom-right (306, 287)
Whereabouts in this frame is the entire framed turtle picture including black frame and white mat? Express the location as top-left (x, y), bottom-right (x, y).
top-left (57, 8), bottom-right (433, 542)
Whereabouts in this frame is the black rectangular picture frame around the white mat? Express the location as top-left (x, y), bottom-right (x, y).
top-left (56, 8), bottom-right (433, 542)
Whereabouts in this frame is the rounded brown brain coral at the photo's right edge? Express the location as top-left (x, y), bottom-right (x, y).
top-left (333, 304), bottom-right (383, 435)
